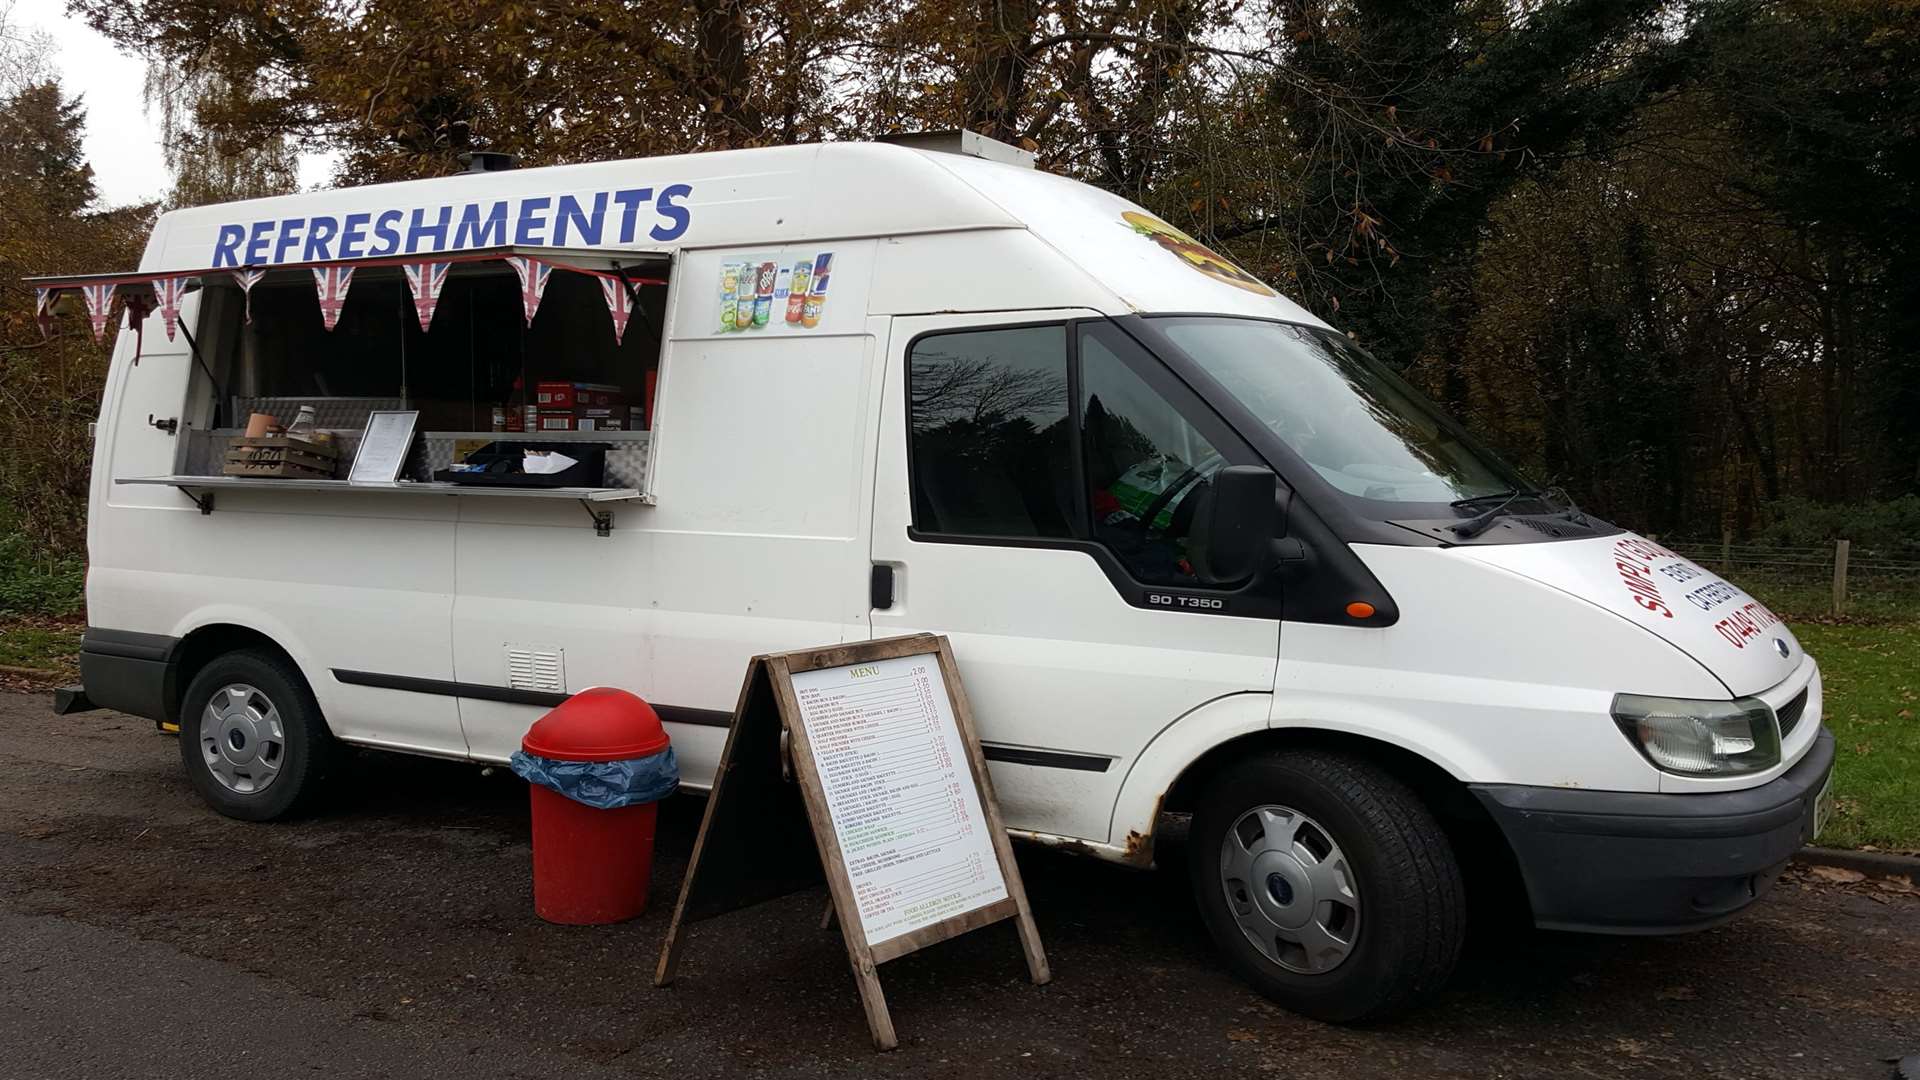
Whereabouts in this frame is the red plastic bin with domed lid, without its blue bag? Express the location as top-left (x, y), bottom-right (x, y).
top-left (520, 686), bottom-right (670, 926)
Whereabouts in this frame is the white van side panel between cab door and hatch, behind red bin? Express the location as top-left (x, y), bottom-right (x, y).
top-left (453, 240), bottom-right (883, 768)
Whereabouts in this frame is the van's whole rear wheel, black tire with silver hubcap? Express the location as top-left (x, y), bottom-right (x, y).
top-left (180, 650), bottom-right (338, 821)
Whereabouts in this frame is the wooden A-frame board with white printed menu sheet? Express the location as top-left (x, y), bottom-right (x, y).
top-left (655, 634), bottom-right (1050, 1049)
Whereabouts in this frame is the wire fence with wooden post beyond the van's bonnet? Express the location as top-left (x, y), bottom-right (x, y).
top-left (1659, 538), bottom-right (1920, 619)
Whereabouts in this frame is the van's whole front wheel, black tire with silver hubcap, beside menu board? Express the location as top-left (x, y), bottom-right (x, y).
top-left (1188, 749), bottom-right (1467, 1022)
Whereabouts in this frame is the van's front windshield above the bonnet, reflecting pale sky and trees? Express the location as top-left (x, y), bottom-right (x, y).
top-left (1154, 317), bottom-right (1530, 519)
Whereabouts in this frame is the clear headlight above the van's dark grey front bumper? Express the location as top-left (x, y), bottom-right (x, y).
top-left (1613, 694), bottom-right (1780, 776)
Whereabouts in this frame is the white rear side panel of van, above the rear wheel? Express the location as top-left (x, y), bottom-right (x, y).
top-left (86, 272), bottom-right (467, 753)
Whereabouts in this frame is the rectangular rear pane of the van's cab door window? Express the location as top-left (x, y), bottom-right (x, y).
top-left (908, 327), bottom-right (1077, 538)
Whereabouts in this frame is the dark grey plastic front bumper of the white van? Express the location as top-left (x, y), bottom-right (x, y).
top-left (1473, 728), bottom-right (1834, 934)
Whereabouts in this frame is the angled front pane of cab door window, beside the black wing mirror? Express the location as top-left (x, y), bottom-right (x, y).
top-left (1079, 325), bottom-right (1227, 586)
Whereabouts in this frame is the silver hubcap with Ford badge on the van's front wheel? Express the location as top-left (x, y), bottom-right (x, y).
top-left (1219, 807), bottom-right (1359, 974)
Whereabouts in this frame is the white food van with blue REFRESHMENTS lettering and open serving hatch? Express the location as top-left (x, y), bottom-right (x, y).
top-left (38, 136), bottom-right (1834, 1020)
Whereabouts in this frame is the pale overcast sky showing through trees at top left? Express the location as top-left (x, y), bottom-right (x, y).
top-left (13, 0), bottom-right (332, 206)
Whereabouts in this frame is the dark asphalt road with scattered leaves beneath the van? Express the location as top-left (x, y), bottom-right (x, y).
top-left (0, 694), bottom-right (1920, 1080)
